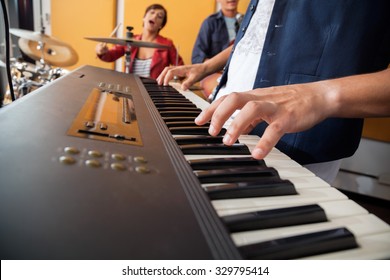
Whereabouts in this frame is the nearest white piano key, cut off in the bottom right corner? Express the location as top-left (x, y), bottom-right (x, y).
top-left (302, 232), bottom-right (390, 260)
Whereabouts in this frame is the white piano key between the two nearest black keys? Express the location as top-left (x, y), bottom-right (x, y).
top-left (231, 214), bottom-right (390, 246)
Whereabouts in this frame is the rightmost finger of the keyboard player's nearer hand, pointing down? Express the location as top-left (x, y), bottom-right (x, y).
top-left (252, 122), bottom-right (285, 159)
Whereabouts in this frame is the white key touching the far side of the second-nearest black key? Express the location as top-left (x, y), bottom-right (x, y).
top-left (218, 199), bottom-right (368, 220)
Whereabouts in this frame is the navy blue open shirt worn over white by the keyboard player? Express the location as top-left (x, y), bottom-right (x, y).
top-left (217, 0), bottom-right (390, 164)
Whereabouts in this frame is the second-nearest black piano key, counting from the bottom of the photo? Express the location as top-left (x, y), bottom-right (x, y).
top-left (222, 204), bottom-right (328, 232)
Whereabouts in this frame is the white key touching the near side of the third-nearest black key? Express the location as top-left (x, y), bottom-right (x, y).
top-left (211, 188), bottom-right (347, 212)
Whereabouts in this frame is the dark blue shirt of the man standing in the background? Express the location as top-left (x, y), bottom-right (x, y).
top-left (191, 11), bottom-right (230, 64)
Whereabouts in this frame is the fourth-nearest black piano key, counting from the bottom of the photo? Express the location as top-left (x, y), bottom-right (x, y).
top-left (194, 166), bottom-right (279, 184)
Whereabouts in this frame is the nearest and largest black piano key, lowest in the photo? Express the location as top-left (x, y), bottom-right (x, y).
top-left (238, 228), bottom-right (358, 260)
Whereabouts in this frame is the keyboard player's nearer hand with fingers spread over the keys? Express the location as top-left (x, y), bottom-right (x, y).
top-left (195, 83), bottom-right (326, 159)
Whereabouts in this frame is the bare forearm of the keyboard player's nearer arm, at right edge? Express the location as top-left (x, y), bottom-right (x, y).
top-left (320, 69), bottom-right (390, 118)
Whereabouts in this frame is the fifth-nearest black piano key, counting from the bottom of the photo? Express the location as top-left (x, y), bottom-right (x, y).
top-left (188, 157), bottom-right (266, 170)
